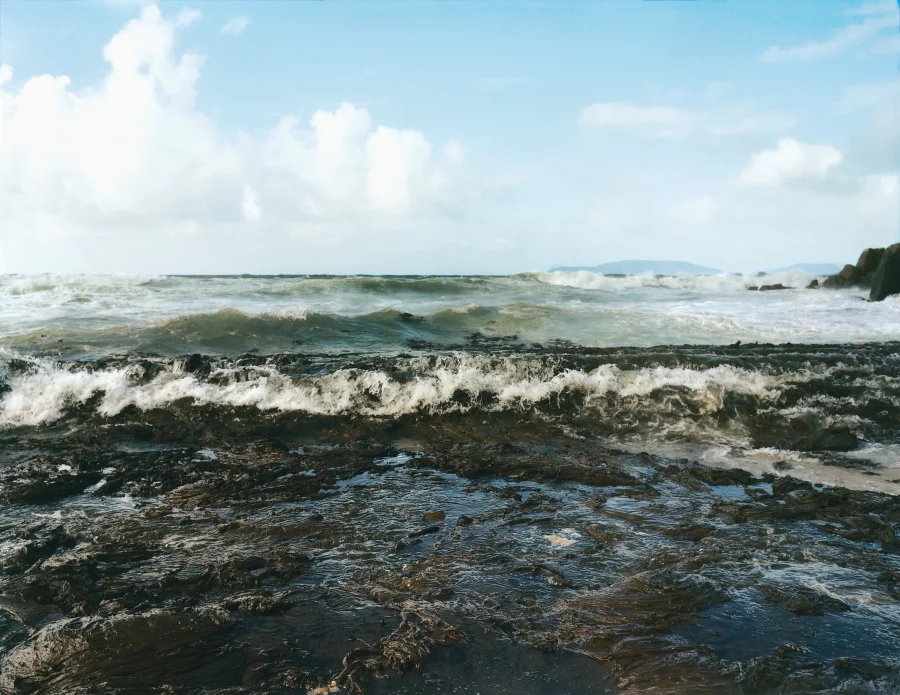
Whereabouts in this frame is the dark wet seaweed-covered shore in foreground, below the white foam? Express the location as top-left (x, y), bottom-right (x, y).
top-left (0, 345), bottom-right (900, 695)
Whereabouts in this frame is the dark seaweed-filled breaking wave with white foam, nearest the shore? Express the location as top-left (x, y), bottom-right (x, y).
top-left (0, 344), bottom-right (900, 492)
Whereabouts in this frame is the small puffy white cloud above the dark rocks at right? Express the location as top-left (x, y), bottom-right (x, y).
top-left (737, 138), bottom-right (844, 186)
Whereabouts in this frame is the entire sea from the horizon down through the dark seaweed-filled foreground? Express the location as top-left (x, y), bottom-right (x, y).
top-left (0, 271), bottom-right (900, 695)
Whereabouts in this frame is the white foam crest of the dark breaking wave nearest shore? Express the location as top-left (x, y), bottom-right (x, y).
top-left (0, 356), bottom-right (782, 427)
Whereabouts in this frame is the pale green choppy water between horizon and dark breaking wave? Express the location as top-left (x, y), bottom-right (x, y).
top-left (0, 272), bottom-right (900, 356)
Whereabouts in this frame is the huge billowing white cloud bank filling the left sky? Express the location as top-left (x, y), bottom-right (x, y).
top-left (0, 6), bottom-right (472, 271)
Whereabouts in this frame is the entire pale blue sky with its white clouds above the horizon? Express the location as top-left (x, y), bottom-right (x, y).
top-left (0, 0), bottom-right (900, 274)
